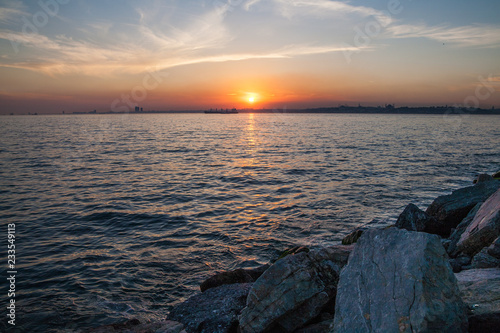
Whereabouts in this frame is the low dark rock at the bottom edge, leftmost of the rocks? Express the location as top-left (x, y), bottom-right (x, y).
top-left (87, 319), bottom-right (186, 333)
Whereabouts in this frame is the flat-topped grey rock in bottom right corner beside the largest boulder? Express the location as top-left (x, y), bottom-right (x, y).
top-left (455, 268), bottom-right (500, 333)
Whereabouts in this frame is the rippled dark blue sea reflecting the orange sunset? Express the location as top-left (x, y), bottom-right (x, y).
top-left (0, 112), bottom-right (500, 332)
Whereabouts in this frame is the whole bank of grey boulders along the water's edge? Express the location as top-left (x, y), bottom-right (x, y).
top-left (89, 173), bottom-right (500, 333)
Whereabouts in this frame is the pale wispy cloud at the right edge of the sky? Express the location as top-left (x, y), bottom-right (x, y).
top-left (387, 24), bottom-right (500, 48)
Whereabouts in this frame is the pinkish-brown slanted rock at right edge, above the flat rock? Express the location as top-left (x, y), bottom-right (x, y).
top-left (457, 188), bottom-right (500, 256)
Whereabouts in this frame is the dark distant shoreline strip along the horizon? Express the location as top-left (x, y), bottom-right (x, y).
top-left (3, 105), bottom-right (500, 116)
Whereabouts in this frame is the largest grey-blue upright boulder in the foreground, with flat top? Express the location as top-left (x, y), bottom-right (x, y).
top-left (331, 228), bottom-right (467, 333)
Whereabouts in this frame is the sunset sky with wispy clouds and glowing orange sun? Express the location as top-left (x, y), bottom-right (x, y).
top-left (0, 0), bottom-right (500, 114)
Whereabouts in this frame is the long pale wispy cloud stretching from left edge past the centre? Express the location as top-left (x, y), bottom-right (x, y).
top-left (0, 25), bottom-right (368, 77)
